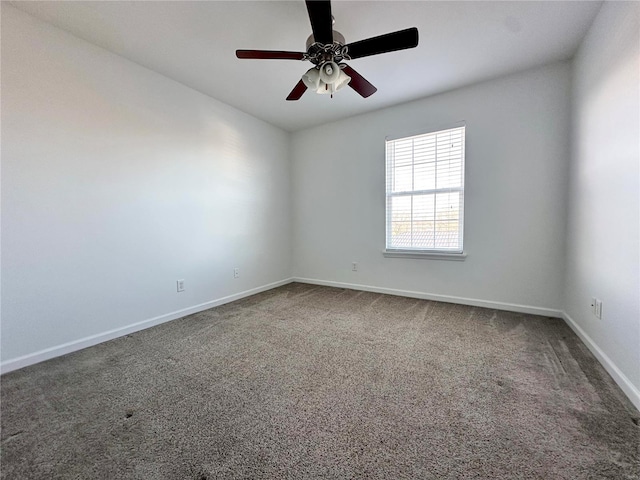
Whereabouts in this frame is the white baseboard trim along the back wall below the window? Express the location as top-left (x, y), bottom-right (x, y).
top-left (293, 277), bottom-right (562, 318)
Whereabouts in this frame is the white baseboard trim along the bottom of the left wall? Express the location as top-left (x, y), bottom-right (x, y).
top-left (0, 278), bottom-right (293, 374)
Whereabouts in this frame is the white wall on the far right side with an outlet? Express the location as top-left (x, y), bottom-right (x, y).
top-left (564, 2), bottom-right (640, 408)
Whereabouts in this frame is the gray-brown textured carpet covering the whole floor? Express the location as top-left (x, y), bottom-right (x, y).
top-left (1, 283), bottom-right (640, 480)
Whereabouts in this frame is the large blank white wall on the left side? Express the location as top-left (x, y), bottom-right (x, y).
top-left (2, 2), bottom-right (291, 366)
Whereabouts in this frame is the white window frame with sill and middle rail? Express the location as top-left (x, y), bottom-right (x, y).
top-left (382, 122), bottom-right (467, 261)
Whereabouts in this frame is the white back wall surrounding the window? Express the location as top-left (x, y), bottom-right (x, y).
top-left (292, 63), bottom-right (570, 315)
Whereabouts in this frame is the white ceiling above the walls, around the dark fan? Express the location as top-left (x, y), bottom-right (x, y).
top-left (10, 0), bottom-right (601, 131)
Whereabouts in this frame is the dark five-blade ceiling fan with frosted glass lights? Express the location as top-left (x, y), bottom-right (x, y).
top-left (236, 0), bottom-right (418, 100)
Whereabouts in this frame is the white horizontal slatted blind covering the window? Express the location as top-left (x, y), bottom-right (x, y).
top-left (386, 127), bottom-right (465, 253)
